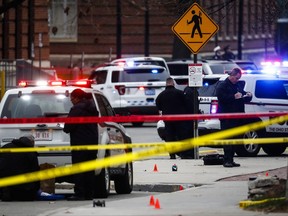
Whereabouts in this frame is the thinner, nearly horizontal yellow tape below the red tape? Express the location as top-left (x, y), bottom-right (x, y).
top-left (0, 137), bottom-right (288, 153)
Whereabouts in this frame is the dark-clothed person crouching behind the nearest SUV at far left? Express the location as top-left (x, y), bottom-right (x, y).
top-left (0, 135), bottom-right (40, 201)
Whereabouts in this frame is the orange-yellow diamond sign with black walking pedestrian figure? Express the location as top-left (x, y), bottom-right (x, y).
top-left (172, 3), bottom-right (219, 53)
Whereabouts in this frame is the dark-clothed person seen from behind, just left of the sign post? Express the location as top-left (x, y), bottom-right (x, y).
top-left (156, 77), bottom-right (185, 159)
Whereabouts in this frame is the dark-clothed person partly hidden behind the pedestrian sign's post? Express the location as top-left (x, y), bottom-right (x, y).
top-left (182, 86), bottom-right (199, 159)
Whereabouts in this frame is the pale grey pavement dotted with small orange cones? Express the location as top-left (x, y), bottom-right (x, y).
top-left (0, 126), bottom-right (288, 216)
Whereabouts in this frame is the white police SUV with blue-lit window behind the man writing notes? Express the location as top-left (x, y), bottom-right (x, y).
top-left (198, 74), bottom-right (288, 156)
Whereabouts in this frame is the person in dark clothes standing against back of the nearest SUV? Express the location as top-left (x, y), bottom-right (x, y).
top-left (63, 89), bottom-right (98, 200)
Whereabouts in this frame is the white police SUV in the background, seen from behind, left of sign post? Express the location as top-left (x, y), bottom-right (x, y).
top-left (89, 64), bottom-right (169, 126)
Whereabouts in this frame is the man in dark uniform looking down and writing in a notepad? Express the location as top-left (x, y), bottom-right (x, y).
top-left (216, 68), bottom-right (252, 167)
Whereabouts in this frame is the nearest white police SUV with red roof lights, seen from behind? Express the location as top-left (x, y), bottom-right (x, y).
top-left (0, 81), bottom-right (133, 197)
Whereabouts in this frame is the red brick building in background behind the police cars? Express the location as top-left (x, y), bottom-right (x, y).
top-left (0, 0), bottom-right (281, 71)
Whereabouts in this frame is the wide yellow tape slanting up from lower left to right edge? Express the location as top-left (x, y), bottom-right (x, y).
top-left (0, 115), bottom-right (288, 187)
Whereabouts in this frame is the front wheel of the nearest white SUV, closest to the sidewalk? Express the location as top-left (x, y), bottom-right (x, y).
top-left (114, 163), bottom-right (133, 194)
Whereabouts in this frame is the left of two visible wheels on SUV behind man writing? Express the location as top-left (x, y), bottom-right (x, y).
top-left (235, 131), bottom-right (261, 157)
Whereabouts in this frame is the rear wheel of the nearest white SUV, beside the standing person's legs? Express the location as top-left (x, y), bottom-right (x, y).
top-left (94, 167), bottom-right (110, 198)
